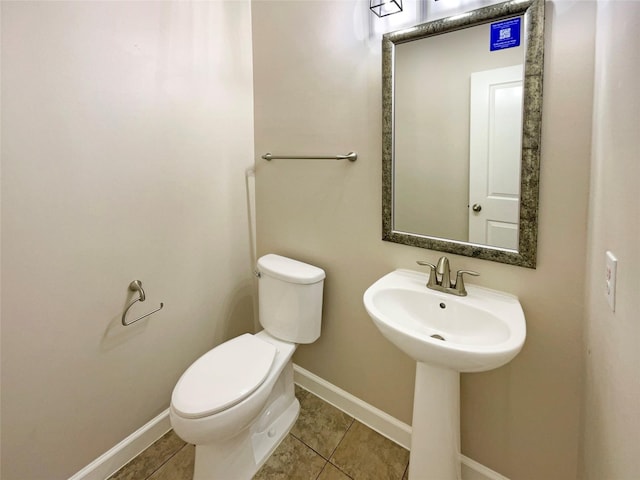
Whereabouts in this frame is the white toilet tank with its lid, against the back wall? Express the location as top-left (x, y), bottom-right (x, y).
top-left (258, 254), bottom-right (325, 343)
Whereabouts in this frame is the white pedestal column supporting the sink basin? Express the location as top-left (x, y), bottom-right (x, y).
top-left (409, 362), bottom-right (461, 480)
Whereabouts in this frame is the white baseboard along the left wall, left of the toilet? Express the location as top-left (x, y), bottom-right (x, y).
top-left (69, 409), bottom-right (171, 480)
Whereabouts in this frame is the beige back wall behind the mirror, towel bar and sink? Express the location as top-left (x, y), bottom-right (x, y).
top-left (252, 1), bottom-right (595, 480)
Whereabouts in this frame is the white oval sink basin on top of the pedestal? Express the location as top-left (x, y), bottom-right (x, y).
top-left (364, 270), bottom-right (526, 372)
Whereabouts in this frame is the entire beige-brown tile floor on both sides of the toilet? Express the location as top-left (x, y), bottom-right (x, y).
top-left (108, 386), bottom-right (409, 480)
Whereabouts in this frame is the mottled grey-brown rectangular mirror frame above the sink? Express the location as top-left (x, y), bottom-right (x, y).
top-left (382, 0), bottom-right (544, 268)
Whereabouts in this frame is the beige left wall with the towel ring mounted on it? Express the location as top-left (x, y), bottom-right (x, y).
top-left (0, 1), bottom-right (253, 480)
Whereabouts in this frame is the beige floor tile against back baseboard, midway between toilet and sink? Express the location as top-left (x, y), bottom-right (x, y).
top-left (291, 386), bottom-right (353, 459)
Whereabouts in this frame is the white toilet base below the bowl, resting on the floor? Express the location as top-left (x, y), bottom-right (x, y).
top-left (193, 362), bottom-right (300, 480)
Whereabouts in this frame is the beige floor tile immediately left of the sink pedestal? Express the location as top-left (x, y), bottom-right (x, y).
top-left (331, 421), bottom-right (409, 480)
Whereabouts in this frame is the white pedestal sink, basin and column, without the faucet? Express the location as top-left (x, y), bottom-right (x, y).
top-left (363, 269), bottom-right (526, 480)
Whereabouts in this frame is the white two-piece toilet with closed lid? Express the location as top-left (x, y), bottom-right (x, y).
top-left (169, 254), bottom-right (325, 480)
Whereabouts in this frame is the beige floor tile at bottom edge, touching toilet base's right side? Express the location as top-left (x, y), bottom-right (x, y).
top-left (253, 435), bottom-right (326, 480)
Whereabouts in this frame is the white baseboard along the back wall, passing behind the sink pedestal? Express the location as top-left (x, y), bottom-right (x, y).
top-left (293, 364), bottom-right (509, 480)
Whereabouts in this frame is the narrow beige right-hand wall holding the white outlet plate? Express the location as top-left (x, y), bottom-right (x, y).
top-left (580, 1), bottom-right (640, 480)
